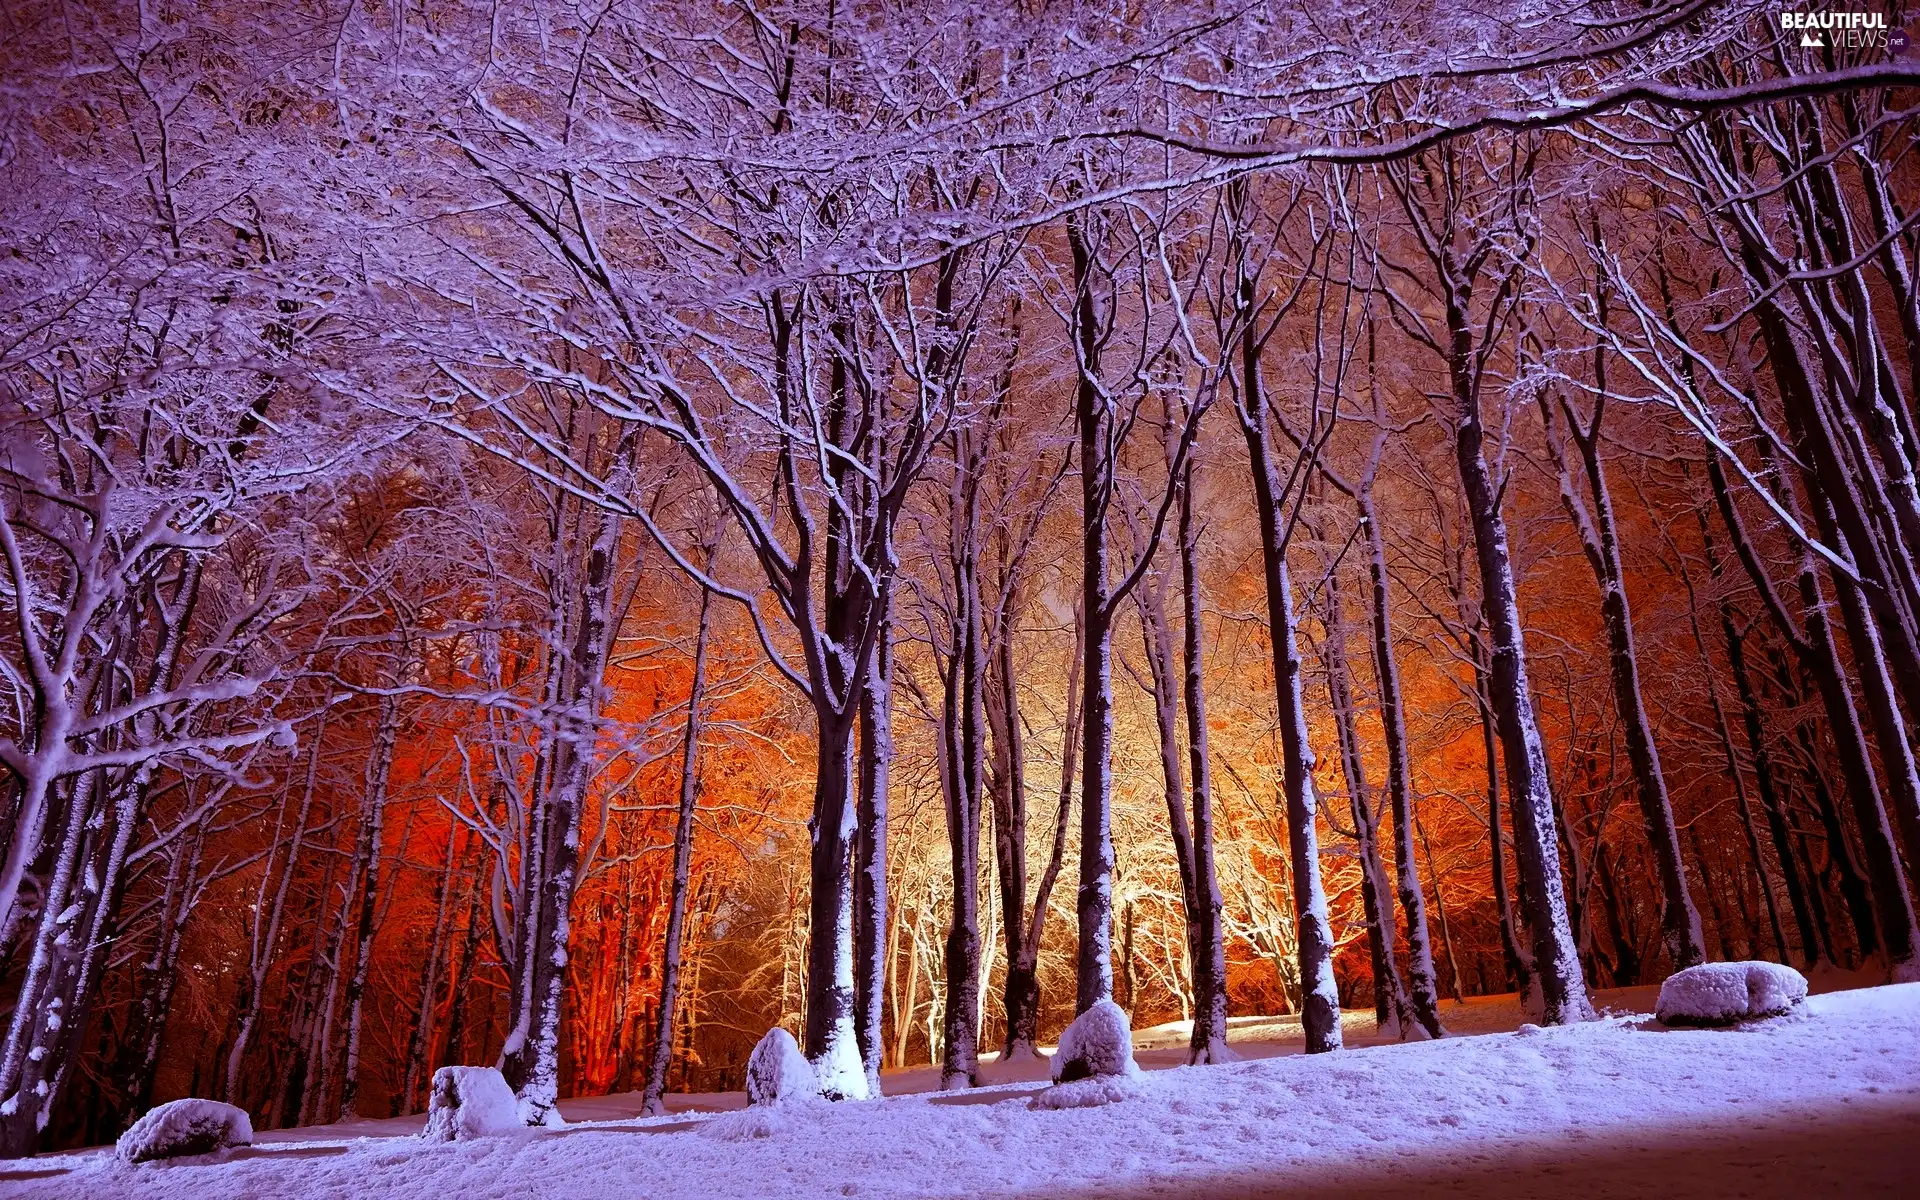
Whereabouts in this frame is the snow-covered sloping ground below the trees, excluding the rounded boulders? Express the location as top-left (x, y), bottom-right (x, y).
top-left (0, 979), bottom-right (1920, 1200)
